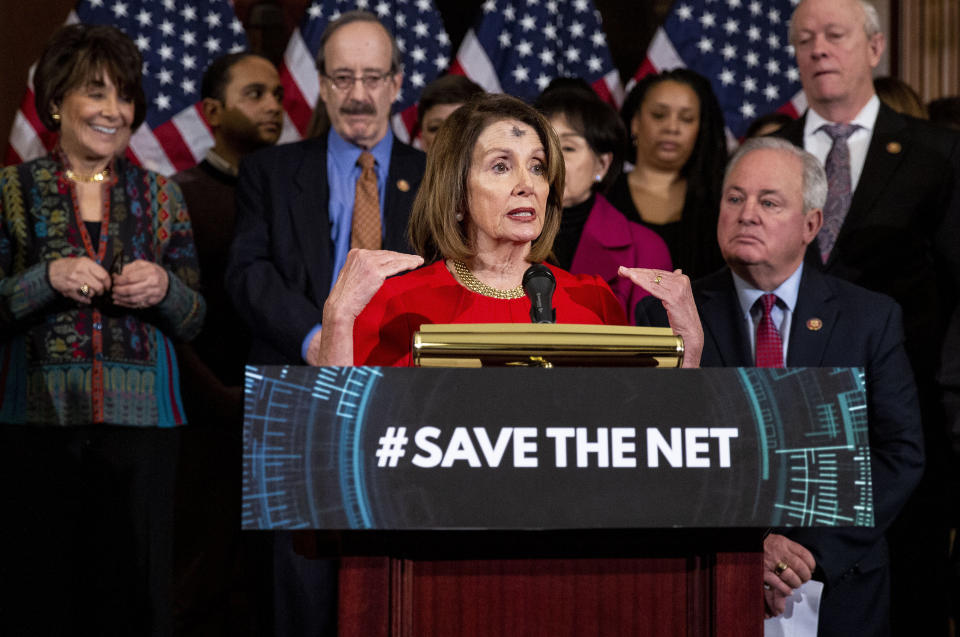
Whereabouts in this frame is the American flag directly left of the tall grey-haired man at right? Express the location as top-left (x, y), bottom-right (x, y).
top-left (634, 0), bottom-right (807, 137)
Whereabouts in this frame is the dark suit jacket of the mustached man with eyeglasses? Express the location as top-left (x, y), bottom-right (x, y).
top-left (226, 136), bottom-right (426, 364)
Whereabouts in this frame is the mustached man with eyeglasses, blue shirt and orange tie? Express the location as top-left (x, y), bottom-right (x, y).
top-left (226, 11), bottom-right (426, 636)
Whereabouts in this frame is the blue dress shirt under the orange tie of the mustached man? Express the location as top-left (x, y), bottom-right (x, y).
top-left (300, 127), bottom-right (393, 361)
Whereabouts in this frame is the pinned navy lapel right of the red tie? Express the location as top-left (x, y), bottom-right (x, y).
top-left (787, 267), bottom-right (839, 367)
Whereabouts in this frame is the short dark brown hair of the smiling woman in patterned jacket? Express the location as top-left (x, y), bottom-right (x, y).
top-left (33, 24), bottom-right (147, 131)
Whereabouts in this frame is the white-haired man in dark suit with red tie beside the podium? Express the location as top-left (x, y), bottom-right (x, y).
top-left (637, 138), bottom-right (923, 637)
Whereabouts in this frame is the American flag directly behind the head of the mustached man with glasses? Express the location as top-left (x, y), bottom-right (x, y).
top-left (280, 0), bottom-right (450, 142)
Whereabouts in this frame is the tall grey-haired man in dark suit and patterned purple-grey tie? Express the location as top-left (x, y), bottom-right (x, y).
top-left (777, 0), bottom-right (960, 635)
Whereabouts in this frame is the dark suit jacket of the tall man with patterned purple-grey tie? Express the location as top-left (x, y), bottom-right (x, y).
top-left (776, 104), bottom-right (960, 403)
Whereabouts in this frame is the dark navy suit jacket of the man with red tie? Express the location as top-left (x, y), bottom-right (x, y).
top-left (637, 267), bottom-right (923, 635)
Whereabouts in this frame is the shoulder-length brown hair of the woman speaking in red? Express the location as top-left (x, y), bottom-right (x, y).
top-left (410, 95), bottom-right (564, 263)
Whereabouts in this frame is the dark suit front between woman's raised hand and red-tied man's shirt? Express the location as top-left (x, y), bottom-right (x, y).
top-left (696, 269), bottom-right (753, 367)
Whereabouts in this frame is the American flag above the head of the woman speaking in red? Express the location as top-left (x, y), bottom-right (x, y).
top-left (452, 0), bottom-right (623, 105)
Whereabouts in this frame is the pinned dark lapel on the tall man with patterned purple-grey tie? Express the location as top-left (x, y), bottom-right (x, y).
top-left (825, 104), bottom-right (909, 268)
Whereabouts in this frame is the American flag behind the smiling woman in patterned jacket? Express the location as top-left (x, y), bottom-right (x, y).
top-left (6, 0), bottom-right (247, 175)
